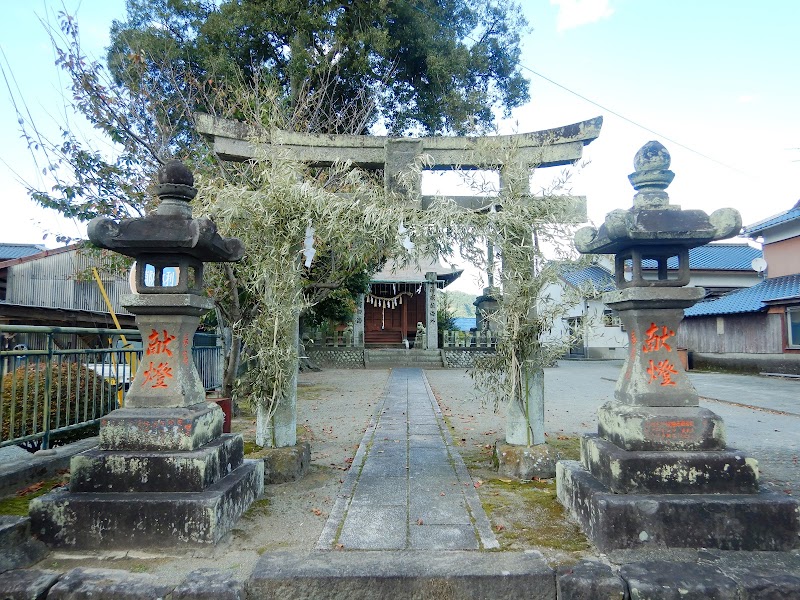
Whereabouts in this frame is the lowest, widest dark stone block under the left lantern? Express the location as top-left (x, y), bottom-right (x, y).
top-left (30, 460), bottom-right (264, 549)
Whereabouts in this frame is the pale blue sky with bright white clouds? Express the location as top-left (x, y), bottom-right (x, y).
top-left (0, 0), bottom-right (800, 290)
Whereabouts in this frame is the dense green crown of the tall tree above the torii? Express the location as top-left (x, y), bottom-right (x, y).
top-left (108, 0), bottom-right (528, 134)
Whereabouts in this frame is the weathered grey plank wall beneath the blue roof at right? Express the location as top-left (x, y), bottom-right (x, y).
top-left (678, 313), bottom-right (783, 354)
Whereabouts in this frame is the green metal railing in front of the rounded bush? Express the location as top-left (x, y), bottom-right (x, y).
top-left (0, 325), bottom-right (222, 449)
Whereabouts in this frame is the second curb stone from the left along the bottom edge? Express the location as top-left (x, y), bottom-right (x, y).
top-left (47, 568), bottom-right (173, 600)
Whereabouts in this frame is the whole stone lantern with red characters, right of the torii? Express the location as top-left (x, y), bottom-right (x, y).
top-left (556, 142), bottom-right (800, 552)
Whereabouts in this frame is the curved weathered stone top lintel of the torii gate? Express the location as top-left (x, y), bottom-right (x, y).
top-left (195, 113), bottom-right (603, 169)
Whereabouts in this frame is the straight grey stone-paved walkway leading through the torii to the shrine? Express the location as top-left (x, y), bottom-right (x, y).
top-left (317, 368), bottom-right (498, 550)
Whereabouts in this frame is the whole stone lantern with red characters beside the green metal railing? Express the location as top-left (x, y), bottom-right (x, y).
top-left (30, 161), bottom-right (264, 549)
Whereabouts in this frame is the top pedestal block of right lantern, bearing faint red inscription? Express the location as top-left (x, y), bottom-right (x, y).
top-left (597, 402), bottom-right (725, 451)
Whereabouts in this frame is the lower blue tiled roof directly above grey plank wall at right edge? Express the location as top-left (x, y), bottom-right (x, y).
top-left (685, 274), bottom-right (800, 317)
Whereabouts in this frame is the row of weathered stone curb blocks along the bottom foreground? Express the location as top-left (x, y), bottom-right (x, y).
top-left (0, 550), bottom-right (800, 600)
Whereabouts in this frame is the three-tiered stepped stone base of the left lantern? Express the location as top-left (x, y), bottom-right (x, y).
top-left (30, 403), bottom-right (264, 549)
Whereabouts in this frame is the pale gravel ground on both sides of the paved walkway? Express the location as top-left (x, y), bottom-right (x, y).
top-left (34, 361), bottom-right (800, 583)
